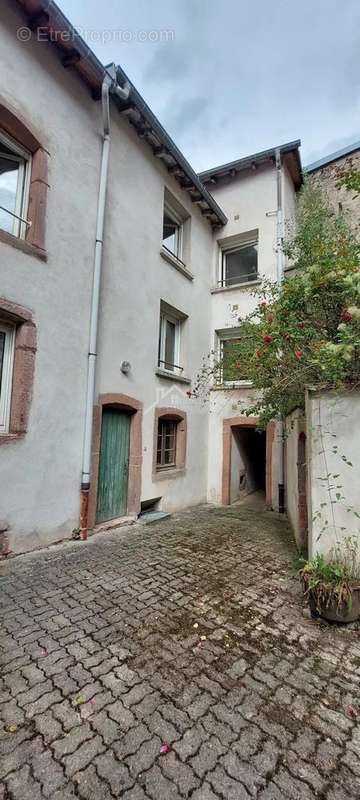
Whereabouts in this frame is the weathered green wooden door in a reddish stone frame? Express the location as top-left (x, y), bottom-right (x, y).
top-left (96, 408), bottom-right (130, 522)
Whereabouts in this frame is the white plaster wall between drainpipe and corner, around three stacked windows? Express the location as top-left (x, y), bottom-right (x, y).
top-left (97, 109), bottom-right (212, 510)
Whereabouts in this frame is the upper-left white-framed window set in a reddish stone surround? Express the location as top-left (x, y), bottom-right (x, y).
top-left (0, 130), bottom-right (31, 238)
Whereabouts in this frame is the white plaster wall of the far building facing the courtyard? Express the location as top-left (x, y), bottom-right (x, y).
top-left (208, 164), bottom-right (295, 509)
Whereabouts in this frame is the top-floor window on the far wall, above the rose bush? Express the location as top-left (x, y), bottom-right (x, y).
top-left (219, 237), bottom-right (258, 286)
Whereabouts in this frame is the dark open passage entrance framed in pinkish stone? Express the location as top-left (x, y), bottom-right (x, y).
top-left (230, 426), bottom-right (266, 503)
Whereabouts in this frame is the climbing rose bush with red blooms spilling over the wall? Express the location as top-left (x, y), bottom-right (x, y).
top-left (195, 183), bottom-right (360, 427)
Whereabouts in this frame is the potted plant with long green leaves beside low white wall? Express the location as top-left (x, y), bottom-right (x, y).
top-left (299, 537), bottom-right (360, 623)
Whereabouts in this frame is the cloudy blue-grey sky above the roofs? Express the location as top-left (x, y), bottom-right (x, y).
top-left (58, 0), bottom-right (360, 171)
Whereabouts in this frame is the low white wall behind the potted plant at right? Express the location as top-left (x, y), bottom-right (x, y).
top-left (306, 389), bottom-right (360, 557)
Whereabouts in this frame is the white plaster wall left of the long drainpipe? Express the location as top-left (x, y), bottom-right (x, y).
top-left (0, 2), bottom-right (101, 550)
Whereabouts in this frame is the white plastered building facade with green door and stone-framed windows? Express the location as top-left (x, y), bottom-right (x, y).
top-left (0, 0), bottom-right (301, 552)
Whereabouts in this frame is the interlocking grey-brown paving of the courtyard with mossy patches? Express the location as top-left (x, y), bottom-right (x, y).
top-left (0, 504), bottom-right (360, 800)
